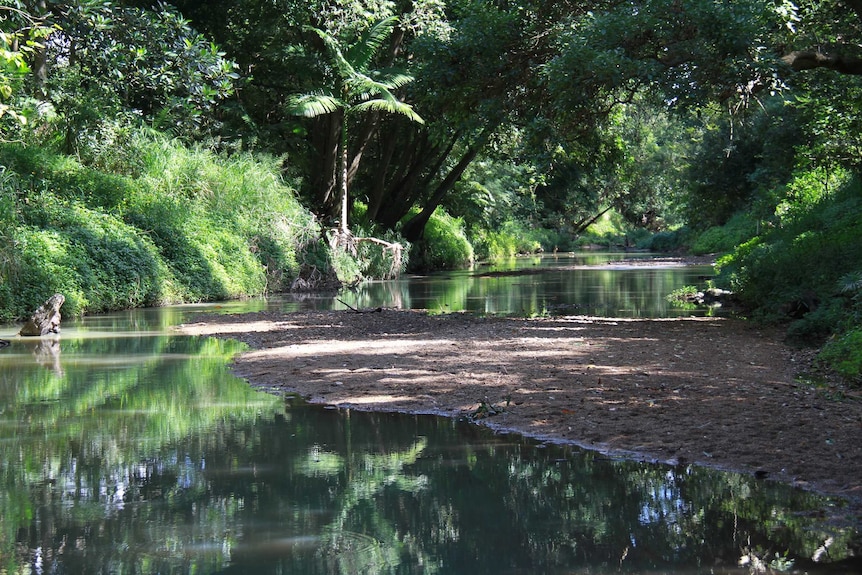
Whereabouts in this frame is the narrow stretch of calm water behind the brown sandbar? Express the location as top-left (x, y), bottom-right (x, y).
top-left (174, 252), bottom-right (717, 318)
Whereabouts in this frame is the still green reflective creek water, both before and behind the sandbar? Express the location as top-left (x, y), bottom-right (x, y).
top-left (0, 254), bottom-right (860, 574)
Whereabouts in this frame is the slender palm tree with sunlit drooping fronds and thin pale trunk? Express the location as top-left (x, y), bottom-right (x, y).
top-left (289, 17), bottom-right (424, 247)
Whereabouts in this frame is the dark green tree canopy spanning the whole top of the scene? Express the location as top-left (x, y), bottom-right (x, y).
top-left (5, 0), bottom-right (862, 240)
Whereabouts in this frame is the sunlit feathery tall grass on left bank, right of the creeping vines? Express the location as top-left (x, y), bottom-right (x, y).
top-left (126, 139), bottom-right (319, 297)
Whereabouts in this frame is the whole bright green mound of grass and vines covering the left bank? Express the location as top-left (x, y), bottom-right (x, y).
top-left (0, 132), bottom-right (319, 321)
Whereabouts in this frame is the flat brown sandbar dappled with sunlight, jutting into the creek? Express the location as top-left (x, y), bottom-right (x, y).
top-left (177, 309), bottom-right (862, 519)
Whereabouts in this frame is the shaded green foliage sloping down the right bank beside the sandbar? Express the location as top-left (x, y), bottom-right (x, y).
top-left (720, 173), bottom-right (862, 378)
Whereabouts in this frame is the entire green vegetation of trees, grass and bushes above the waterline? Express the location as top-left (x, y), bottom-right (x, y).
top-left (0, 0), bottom-right (862, 375)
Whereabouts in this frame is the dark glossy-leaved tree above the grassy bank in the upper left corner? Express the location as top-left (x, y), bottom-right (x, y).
top-left (2, 0), bottom-right (237, 152)
